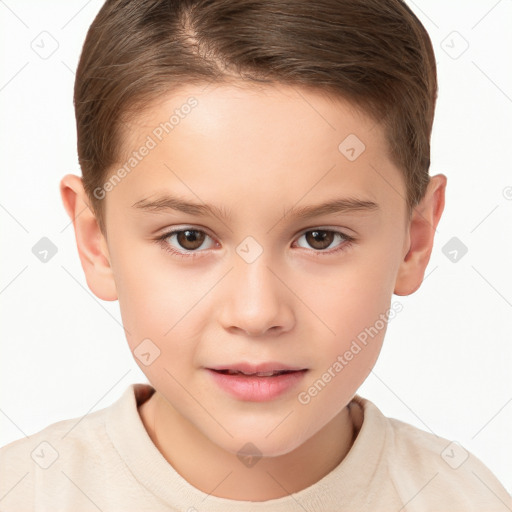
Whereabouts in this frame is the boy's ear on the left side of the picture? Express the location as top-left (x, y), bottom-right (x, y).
top-left (60, 174), bottom-right (117, 300)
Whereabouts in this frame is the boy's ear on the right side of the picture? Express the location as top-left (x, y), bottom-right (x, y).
top-left (394, 174), bottom-right (447, 295)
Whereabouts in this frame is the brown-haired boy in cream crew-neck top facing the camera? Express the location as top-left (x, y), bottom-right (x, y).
top-left (0, 0), bottom-right (512, 512)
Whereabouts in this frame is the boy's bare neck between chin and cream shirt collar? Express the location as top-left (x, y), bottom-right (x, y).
top-left (139, 391), bottom-right (356, 501)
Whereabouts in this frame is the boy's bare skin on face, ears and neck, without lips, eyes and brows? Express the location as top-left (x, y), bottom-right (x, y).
top-left (61, 84), bottom-right (447, 501)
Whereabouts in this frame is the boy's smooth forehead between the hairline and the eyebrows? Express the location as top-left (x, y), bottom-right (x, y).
top-left (107, 84), bottom-right (405, 221)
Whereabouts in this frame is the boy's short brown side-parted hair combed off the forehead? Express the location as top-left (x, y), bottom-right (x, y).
top-left (74, 0), bottom-right (437, 233)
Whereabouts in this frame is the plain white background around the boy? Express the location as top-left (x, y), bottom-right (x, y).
top-left (0, 0), bottom-right (512, 498)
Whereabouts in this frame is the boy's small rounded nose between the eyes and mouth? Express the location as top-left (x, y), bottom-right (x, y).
top-left (220, 252), bottom-right (295, 337)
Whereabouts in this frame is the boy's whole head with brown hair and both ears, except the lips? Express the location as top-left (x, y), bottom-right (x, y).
top-left (61, 0), bottom-right (446, 456)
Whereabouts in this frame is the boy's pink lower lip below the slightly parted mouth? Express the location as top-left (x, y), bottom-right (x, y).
top-left (208, 369), bottom-right (307, 402)
